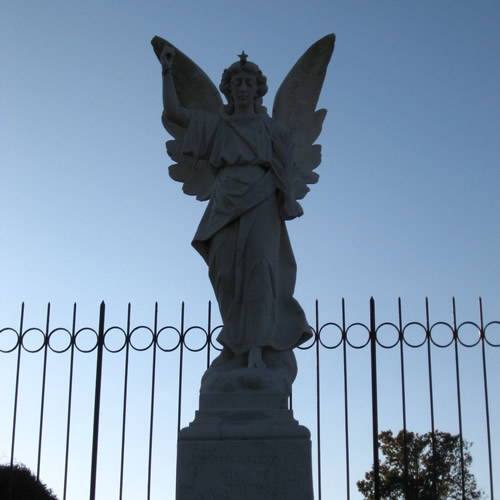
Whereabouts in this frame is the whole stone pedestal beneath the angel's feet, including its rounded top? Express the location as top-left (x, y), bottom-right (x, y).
top-left (176, 352), bottom-right (313, 500)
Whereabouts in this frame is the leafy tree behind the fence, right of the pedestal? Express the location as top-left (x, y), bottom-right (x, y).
top-left (356, 430), bottom-right (485, 500)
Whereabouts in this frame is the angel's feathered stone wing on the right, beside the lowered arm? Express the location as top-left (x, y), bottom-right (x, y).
top-left (273, 34), bottom-right (335, 200)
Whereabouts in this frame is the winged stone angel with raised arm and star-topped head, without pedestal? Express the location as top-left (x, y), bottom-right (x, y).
top-left (152, 34), bottom-right (335, 398)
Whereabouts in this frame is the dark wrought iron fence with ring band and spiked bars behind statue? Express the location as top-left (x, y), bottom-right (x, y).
top-left (0, 299), bottom-right (500, 500)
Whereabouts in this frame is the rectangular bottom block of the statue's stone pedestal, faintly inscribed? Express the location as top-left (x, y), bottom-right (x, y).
top-left (176, 438), bottom-right (313, 500)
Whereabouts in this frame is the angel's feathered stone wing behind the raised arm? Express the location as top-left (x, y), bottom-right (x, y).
top-left (151, 36), bottom-right (222, 201)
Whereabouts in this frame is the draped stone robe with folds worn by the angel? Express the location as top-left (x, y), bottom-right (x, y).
top-left (183, 111), bottom-right (311, 353)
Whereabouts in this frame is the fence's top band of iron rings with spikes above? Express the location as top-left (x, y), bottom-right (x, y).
top-left (0, 299), bottom-right (500, 353)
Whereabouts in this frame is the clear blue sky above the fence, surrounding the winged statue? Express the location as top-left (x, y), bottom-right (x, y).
top-left (0, 0), bottom-right (500, 498)
